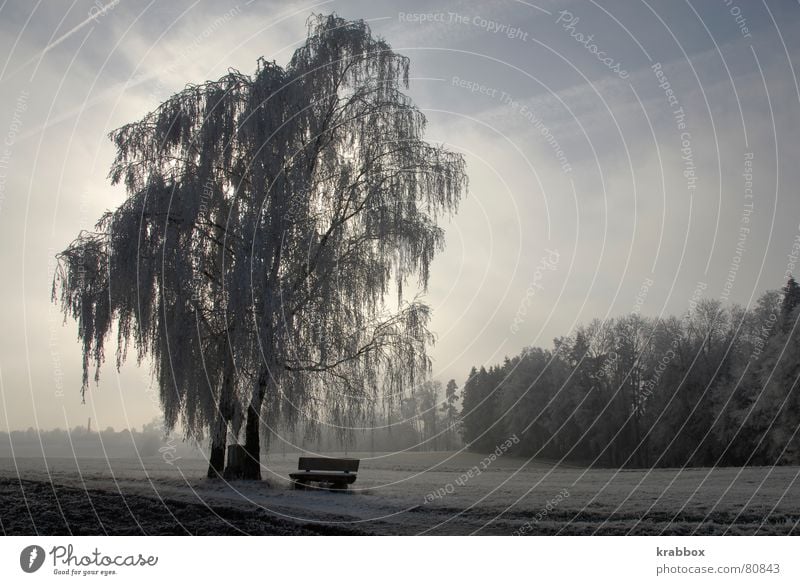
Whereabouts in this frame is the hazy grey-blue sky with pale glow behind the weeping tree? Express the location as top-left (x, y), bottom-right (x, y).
top-left (0, 0), bottom-right (800, 429)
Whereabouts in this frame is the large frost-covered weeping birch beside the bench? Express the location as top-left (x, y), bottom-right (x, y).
top-left (53, 15), bottom-right (466, 478)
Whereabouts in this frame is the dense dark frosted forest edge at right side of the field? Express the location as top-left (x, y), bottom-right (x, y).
top-left (460, 278), bottom-right (800, 467)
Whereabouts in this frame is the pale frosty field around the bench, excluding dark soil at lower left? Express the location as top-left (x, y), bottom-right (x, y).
top-left (0, 453), bottom-right (800, 534)
